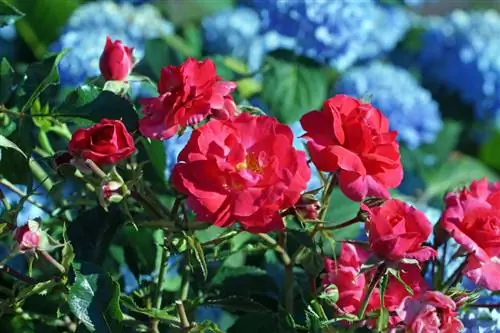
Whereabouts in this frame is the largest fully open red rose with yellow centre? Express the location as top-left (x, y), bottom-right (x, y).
top-left (172, 113), bottom-right (311, 232)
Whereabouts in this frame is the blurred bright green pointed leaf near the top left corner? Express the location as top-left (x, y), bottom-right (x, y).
top-left (9, 0), bottom-right (78, 57)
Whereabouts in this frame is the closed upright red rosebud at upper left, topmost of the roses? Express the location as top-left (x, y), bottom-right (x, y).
top-left (99, 36), bottom-right (134, 81)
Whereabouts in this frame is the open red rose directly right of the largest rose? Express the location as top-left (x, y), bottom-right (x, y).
top-left (300, 95), bottom-right (403, 201)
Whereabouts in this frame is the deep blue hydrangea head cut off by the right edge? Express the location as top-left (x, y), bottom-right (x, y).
top-left (420, 10), bottom-right (500, 125)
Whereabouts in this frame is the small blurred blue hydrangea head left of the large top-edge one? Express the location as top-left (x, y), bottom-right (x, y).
top-left (201, 7), bottom-right (260, 60)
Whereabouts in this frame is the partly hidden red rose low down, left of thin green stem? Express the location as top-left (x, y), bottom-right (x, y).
top-left (322, 243), bottom-right (380, 314)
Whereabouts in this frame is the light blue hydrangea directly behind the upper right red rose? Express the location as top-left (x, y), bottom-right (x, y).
top-left (335, 62), bottom-right (443, 149)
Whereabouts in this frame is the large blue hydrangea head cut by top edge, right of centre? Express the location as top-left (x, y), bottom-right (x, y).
top-left (244, 0), bottom-right (409, 70)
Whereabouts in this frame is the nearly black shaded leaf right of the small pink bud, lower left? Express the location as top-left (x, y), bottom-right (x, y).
top-left (68, 205), bottom-right (125, 263)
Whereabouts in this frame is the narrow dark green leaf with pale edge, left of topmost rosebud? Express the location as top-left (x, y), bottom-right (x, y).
top-left (21, 51), bottom-right (66, 112)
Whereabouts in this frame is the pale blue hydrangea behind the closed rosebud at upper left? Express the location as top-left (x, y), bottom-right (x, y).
top-left (50, 1), bottom-right (173, 85)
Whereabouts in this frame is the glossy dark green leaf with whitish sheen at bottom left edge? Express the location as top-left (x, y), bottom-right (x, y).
top-left (68, 262), bottom-right (123, 333)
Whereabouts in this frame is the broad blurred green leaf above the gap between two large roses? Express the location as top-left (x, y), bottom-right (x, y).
top-left (262, 57), bottom-right (328, 124)
